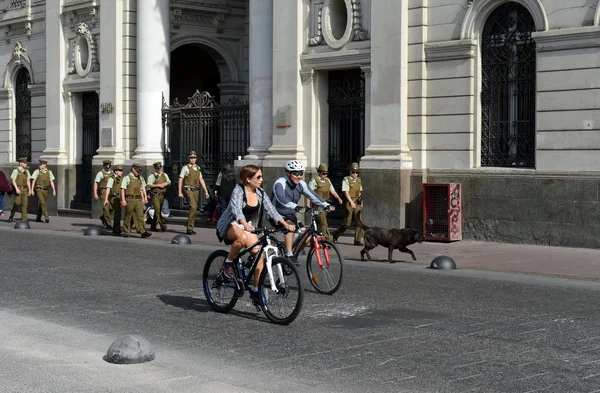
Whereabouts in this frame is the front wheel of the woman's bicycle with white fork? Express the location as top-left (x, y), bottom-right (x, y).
top-left (258, 257), bottom-right (304, 325)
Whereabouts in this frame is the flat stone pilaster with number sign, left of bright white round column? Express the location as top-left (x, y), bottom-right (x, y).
top-left (93, 0), bottom-right (125, 166)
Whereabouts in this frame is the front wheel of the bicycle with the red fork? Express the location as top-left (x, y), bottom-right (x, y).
top-left (306, 239), bottom-right (344, 295)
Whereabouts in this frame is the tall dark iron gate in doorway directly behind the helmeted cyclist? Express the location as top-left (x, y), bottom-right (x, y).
top-left (327, 69), bottom-right (365, 216)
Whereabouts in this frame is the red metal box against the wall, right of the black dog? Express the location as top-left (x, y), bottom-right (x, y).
top-left (423, 183), bottom-right (462, 241)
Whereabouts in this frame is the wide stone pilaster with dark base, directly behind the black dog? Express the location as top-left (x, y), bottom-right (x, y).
top-left (360, 0), bottom-right (412, 227)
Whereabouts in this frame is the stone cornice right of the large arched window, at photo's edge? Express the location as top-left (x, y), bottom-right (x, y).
top-left (532, 26), bottom-right (600, 52)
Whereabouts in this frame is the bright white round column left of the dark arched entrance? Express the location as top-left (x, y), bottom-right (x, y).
top-left (133, 0), bottom-right (171, 164)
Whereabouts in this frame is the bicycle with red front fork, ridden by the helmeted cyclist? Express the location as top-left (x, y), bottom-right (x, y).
top-left (277, 207), bottom-right (344, 295)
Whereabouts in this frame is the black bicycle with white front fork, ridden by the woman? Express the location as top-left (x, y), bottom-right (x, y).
top-left (203, 228), bottom-right (304, 325)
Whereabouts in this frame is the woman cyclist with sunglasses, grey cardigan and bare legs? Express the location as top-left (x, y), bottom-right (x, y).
top-left (217, 165), bottom-right (296, 303)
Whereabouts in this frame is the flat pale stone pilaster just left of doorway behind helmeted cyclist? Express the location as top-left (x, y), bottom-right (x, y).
top-left (265, 0), bottom-right (308, 168)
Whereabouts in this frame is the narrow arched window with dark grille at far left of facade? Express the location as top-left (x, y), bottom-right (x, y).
top-left (15, 68), bottom-right (31, 161)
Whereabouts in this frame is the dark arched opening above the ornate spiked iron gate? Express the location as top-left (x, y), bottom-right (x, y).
top-left (169, 44), bottom-right (221, 104)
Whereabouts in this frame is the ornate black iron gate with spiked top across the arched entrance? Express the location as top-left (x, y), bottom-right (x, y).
top-left (162, 90), bottom-right (250, 209)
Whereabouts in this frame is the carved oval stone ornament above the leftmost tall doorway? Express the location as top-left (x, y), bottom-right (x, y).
top-left (67, 23), bottom-right (100, 77)
